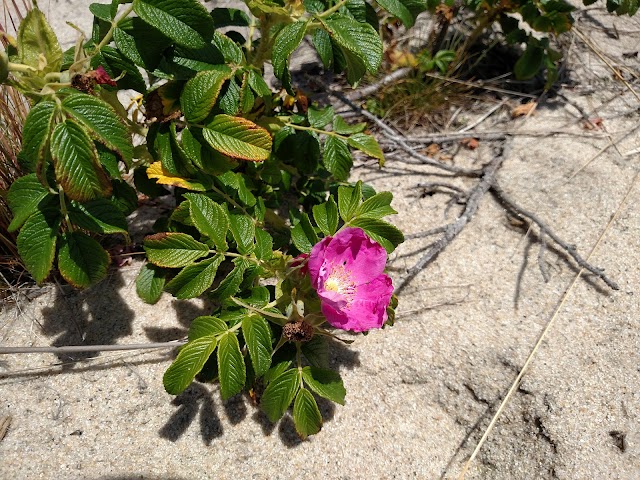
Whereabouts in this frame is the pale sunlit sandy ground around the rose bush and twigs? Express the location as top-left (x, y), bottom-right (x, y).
top-left (0, 1), bottom-right (640, 480)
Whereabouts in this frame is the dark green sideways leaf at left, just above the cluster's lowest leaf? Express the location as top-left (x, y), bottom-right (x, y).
top-left (69, 198), bottom-right (129, 235)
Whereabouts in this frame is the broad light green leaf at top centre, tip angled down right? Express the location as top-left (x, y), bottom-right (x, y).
top-left (323, 13), bottom-right (382, 74)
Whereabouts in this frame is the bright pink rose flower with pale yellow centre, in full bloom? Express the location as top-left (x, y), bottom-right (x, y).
top-left (308, 228), bottom-right (393, 332)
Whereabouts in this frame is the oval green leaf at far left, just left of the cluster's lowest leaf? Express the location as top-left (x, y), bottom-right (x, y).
top-left (16, 204), bottom-right (60, 283)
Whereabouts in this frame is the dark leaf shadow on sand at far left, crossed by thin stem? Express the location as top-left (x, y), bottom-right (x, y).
top-left (41, 270), bottom-right (135, 369)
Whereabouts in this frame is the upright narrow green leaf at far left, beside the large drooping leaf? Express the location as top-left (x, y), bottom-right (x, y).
top-left (21, 100), bottom-right (57, 172)
